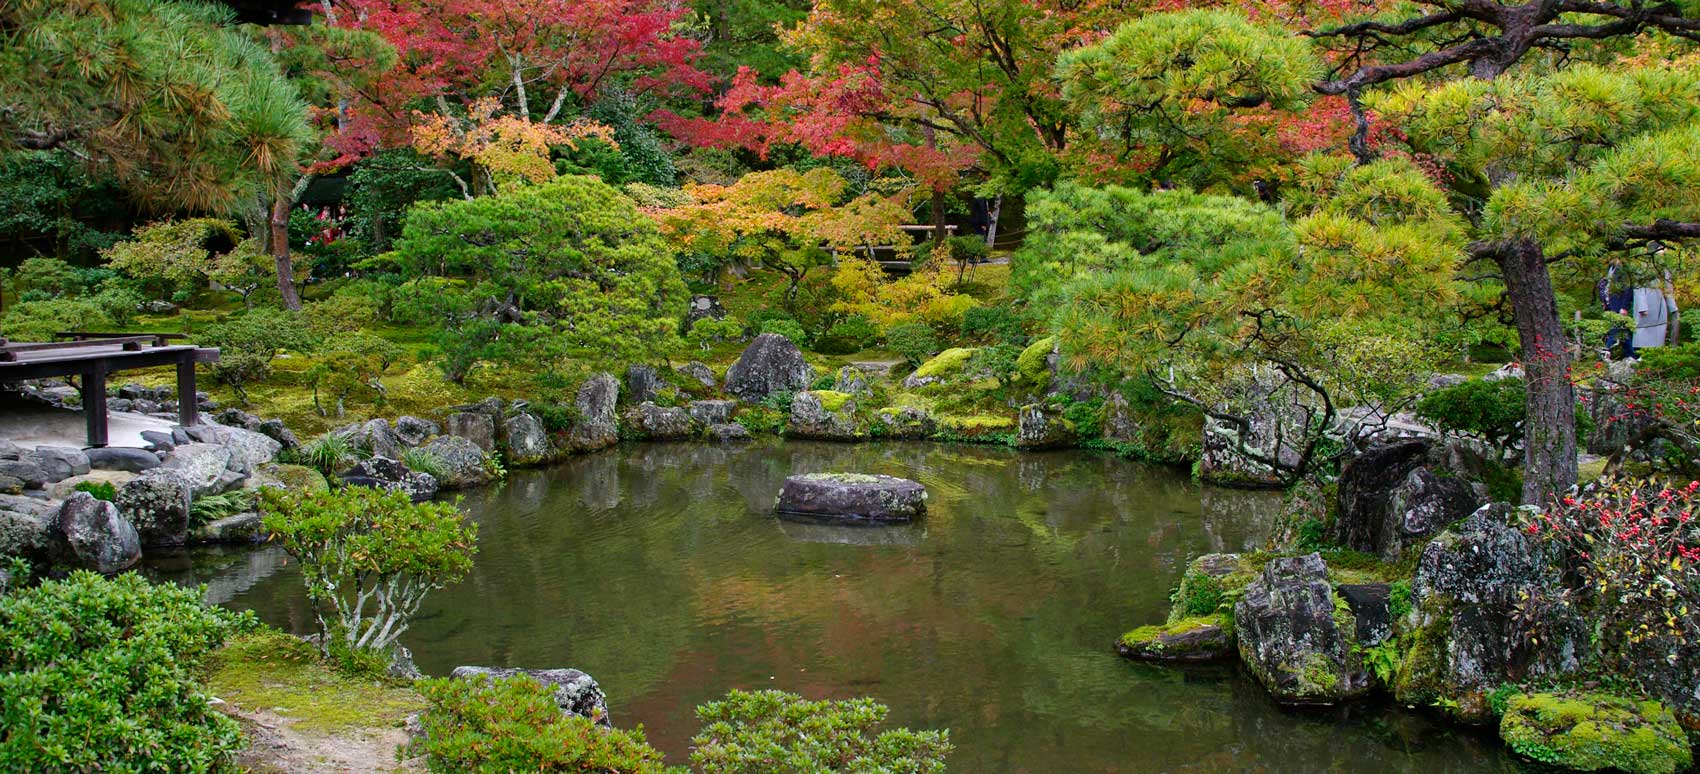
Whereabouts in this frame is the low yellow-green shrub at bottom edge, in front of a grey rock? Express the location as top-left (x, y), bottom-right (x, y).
top-left (408, 675), bottom-right (665, 774)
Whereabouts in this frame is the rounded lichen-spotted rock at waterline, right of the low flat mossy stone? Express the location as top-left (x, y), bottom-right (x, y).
top-left (1234, 553), bottom-right (1372, 704)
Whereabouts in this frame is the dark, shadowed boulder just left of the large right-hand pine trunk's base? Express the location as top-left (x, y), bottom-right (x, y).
top-left (1329, 439), bottom-right (1484, 561)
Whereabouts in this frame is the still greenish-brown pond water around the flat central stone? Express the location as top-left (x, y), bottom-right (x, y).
top-left (153, 442), bottom-right (1518, 772)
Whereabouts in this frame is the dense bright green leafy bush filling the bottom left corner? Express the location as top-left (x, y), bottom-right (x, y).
top-left (0, 572), bottom-right (253, 771)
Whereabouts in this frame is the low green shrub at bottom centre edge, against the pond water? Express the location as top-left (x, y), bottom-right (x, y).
top-left (690, 691), bottom-right (950, 774)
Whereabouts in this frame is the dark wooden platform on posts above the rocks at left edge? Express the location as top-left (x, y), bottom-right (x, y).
top-left (0, 332), bottom-right (218, 447)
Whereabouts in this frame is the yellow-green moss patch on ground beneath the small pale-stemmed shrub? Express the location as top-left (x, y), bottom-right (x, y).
top-left (207, 631), bottom-right (425, 733)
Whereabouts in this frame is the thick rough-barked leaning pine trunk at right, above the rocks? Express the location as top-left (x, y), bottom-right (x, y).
top-left (1494, 240), bottom-right (1576, 505)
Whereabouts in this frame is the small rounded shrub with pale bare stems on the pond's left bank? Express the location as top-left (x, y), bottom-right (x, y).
top-left (260, 487), bottom-right (478, 653)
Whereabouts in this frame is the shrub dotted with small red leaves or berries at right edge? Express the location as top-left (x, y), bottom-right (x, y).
top-left (1523, 481), bottom-right (1700, 658)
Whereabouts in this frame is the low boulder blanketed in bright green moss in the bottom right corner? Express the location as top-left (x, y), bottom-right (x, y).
top-left (1499, 694), bottom-right (1693, 774)
